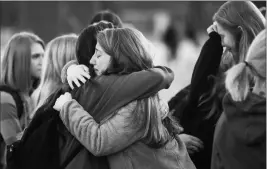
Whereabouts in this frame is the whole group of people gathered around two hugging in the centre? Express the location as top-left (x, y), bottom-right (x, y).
top-left (0, 1), bottom-right (266, 169)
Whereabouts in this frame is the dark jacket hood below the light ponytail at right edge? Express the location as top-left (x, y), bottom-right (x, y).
top-left (223, 93), bottom-right (266, 144)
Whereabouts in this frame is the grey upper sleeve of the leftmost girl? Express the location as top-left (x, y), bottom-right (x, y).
top-left (0, 99), bottom-right (22, 145)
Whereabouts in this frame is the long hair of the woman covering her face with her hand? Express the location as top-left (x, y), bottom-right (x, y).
top-left (199, 1), bottom-right (266, 118)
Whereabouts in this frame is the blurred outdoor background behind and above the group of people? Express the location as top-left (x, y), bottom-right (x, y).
top-left (0, 1), bottom-right (266, 100)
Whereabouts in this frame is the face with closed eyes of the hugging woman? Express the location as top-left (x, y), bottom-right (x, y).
top-left (90, 43), bottom-right (111, 76)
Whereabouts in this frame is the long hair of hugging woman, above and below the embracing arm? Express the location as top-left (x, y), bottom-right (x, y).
top-left (97, 28), bottom-right (180, 148)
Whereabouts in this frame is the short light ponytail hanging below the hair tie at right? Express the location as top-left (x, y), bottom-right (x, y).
top-left (225, 62), bottom-right (250, 101)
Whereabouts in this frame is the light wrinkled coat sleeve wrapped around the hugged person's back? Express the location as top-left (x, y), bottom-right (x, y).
top-left (60, 100), bottom-right (143, 156)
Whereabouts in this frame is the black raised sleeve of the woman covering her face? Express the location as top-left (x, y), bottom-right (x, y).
top-left (189, 32), bottom-right (223, 105)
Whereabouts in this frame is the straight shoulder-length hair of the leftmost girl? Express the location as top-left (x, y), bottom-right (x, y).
top-left (0, 32), bottom-right (44, 93)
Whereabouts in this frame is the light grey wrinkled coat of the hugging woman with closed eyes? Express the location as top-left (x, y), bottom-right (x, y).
top-left (60, 97), bottom-right (195, 169)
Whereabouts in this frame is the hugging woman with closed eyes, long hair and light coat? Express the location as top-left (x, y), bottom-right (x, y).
top-left (54, 28), bottom-right (195, 169)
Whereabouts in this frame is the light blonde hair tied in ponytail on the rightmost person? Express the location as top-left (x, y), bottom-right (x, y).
top-left (225, 29), bottom-right (266, 101)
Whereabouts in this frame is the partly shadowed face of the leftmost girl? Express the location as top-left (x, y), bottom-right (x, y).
top-left (31, 43), bottom-right (44, 79)
